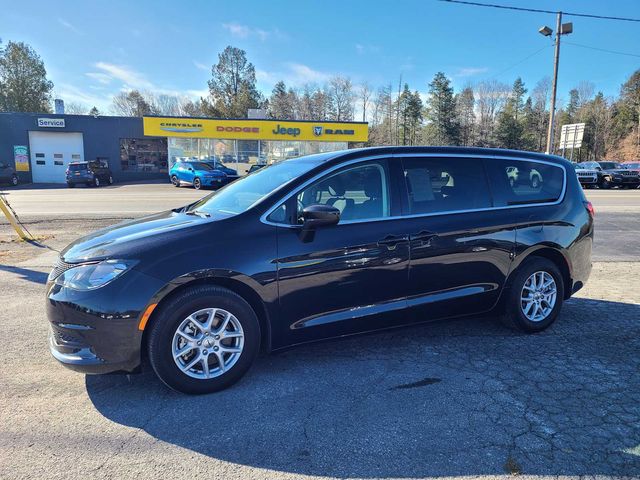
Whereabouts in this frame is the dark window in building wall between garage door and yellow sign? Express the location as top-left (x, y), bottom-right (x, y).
top-left (120, 138), bottom-right (168, 173)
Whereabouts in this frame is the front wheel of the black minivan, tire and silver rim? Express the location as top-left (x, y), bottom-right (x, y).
top-left (148, 285), bottom-right (260, 394)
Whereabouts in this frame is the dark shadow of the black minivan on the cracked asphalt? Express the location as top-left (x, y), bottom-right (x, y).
top-left (86, 299), bottom-right (640, 477)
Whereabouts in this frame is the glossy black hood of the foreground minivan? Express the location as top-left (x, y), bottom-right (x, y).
top-left (61, 211), bottom-right (212, 263)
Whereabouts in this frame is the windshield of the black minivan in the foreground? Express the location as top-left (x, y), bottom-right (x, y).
top-left (189, 154), bottom-right (327, 215)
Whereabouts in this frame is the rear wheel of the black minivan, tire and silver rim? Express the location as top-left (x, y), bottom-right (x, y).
top-left (503, 257), bottom-right (564, 333)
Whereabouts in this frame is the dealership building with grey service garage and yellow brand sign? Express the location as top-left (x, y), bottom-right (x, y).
top-left (0, 113), bottom-right (368, 183)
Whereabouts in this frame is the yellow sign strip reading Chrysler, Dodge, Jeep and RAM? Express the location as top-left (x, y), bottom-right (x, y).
top-left (142, 117), bottom-right (369, 142)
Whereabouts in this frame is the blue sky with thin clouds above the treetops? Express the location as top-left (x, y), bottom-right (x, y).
top-left (0, 0), bottom-right (640, 111)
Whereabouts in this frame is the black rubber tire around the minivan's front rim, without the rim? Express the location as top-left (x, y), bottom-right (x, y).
top-left (147, 285), bottom-right (260, 394)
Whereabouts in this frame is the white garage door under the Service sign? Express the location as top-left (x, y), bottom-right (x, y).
top-left (29, 132), bottom-right (84, 183)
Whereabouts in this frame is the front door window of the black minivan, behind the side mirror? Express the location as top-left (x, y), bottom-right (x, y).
top-left (296, 161), bottom-right (390, 223)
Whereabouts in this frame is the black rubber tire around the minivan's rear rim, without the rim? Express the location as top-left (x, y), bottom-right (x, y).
top-left (502, 257), bottom-right (564, 333)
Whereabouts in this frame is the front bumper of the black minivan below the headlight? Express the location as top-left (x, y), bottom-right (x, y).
top-left (46, 270), bottom-right (161, 374)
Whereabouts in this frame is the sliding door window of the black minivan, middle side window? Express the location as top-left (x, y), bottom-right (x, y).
top-left (402, 158), bottom-right (491, 215)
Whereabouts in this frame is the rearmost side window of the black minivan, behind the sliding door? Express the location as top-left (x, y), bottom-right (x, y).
top-left (485, 158), bottom-right (564, 207)
